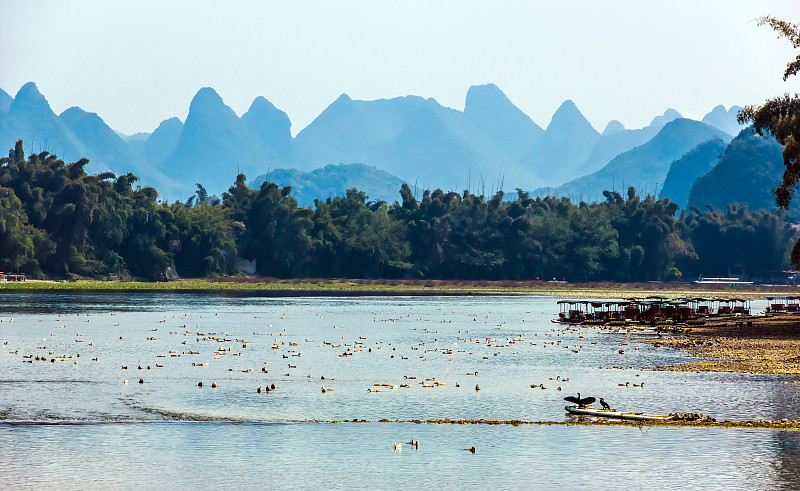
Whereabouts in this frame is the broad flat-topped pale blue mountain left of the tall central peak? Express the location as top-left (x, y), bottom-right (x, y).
top-left (295, 90), bottom-right (543, 194)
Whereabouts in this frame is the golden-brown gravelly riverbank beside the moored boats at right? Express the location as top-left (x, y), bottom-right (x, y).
top-left (652, 315), bottom-right (800, 375)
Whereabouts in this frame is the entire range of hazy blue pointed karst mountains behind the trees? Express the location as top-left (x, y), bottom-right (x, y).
top-left (0, 83), bottom-right (752, 205)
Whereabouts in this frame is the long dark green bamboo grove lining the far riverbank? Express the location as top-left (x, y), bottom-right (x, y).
top-left (0, 142), bottom-right (799, 282)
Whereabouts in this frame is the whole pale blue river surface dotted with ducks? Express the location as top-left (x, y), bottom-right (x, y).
top-left (0, 292), bottom-right (800, 489)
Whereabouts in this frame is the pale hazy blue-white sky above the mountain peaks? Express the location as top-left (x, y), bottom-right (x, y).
top-left (0, 0), bottom-right (800, 133)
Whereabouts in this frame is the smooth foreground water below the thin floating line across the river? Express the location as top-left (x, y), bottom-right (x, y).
top-left (0, 423), bottom-right (799, 489)
